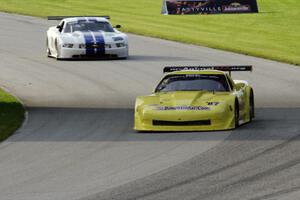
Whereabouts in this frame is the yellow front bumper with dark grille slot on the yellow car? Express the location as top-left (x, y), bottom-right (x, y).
top-left (134, 110), bottom-right (235, 131)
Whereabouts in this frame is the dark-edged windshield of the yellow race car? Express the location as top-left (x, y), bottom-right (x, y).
top-left (155, 74), bottom-right (229, 92)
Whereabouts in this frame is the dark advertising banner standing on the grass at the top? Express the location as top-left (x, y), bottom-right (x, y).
top-left (162, 0), bottom-right (258, 15)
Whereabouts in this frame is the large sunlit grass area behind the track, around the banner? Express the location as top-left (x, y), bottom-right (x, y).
top-left (0, 0), bottom-right (300, 65)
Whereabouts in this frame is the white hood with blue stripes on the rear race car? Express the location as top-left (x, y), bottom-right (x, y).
top-left (61, 31), bottom-right (127, 44)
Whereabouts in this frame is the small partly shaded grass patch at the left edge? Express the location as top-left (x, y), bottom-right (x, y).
top-left (0, 89), bottom-right (25, 141)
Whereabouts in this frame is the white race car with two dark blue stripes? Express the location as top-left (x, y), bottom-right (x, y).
top-left (46, 16), bottom-right (128, 59)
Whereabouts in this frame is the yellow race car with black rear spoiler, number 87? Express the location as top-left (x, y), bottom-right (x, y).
top-left (134, 66), bottom-right (254, 131)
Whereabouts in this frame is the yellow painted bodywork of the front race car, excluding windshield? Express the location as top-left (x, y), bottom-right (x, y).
top-left (134, 70), bottom-right (251, 131)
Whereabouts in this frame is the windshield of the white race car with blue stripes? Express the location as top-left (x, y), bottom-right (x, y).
top-left (64, 21), bottom-right (114, 33)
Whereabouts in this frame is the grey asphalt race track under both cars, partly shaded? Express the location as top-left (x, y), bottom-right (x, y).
top-left (0, 13), bottom-right (300, 200)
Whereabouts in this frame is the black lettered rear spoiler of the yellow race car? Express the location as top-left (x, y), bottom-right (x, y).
top-left (164, 65), bottom-right (252, 74)
